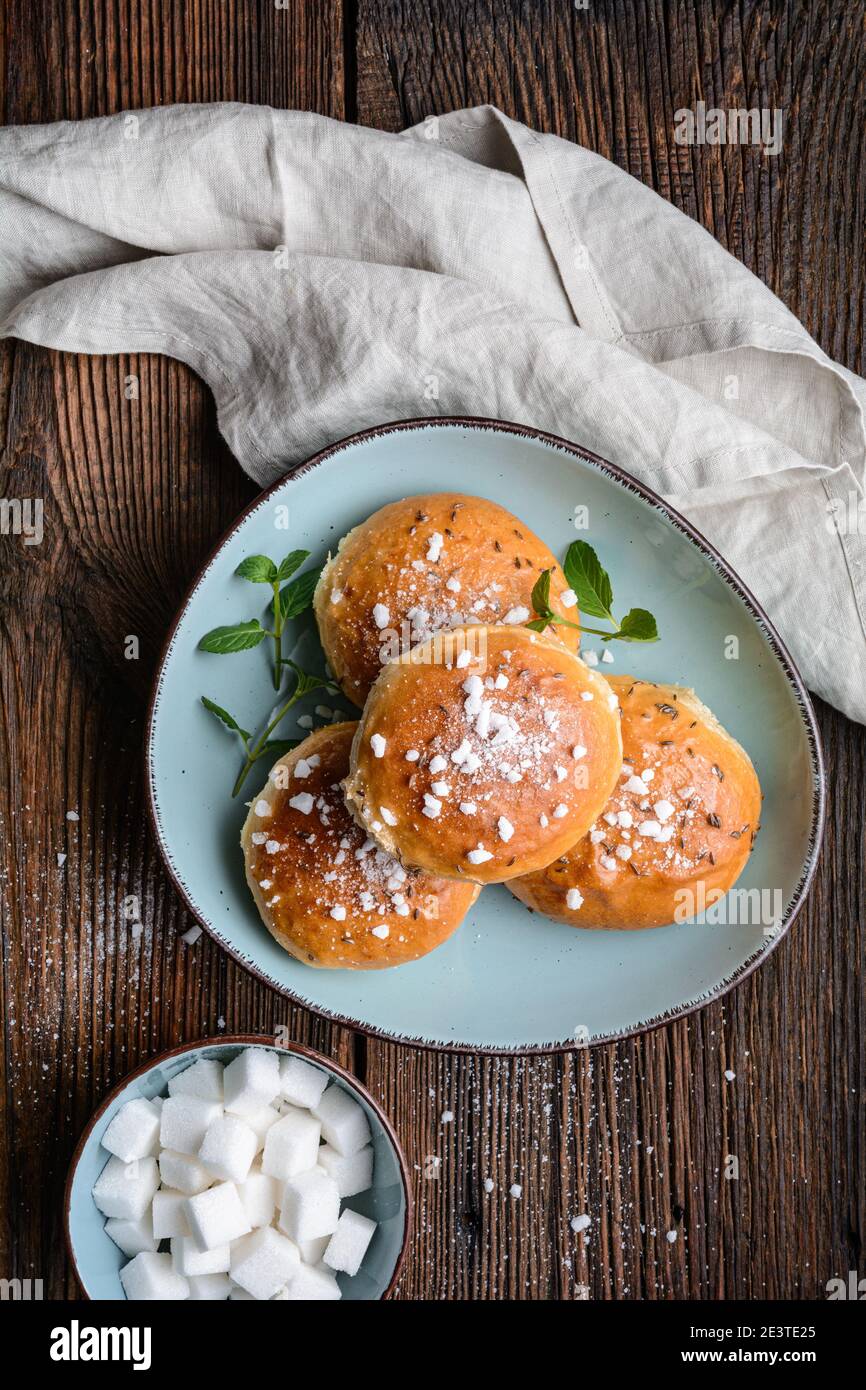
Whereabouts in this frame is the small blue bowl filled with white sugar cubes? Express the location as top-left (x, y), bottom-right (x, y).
top-left (65, 1037), bottom-right (411, 1302)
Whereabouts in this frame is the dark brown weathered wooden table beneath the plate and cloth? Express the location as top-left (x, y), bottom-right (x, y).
top-left (0, 0), bottom-right (866, 1300)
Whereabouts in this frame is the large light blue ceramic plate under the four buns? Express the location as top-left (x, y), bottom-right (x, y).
top-left (147, 420), bottom-right (823, 1052)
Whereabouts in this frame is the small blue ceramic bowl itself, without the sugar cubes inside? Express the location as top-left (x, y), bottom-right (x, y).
top-left (64, 1036), bottom-right (411, 1301)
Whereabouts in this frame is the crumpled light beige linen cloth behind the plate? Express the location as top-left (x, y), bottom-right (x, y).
top-left (0, 104), bottom-right (866, 721)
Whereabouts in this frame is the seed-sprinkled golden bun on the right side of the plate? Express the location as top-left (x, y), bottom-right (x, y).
top-left (509, 676), bottom-right (760, 931)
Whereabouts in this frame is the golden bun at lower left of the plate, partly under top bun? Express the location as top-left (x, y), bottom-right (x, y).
top-left (240, 724), bottom-right (478, 970)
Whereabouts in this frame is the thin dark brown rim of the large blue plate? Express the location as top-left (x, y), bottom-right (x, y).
top-left (143, 416), bottom-right (826, 1056)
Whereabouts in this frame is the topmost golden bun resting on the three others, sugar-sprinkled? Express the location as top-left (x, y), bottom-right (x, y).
top-left (346, 626), bottom-right (623, 883)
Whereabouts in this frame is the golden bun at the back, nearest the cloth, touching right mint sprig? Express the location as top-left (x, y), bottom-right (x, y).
top-left (313, 492), bottom-right (578, 709)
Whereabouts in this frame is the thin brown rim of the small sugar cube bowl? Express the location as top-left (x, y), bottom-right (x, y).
top-left (63, 1033), bottom-right (414, 1302)
